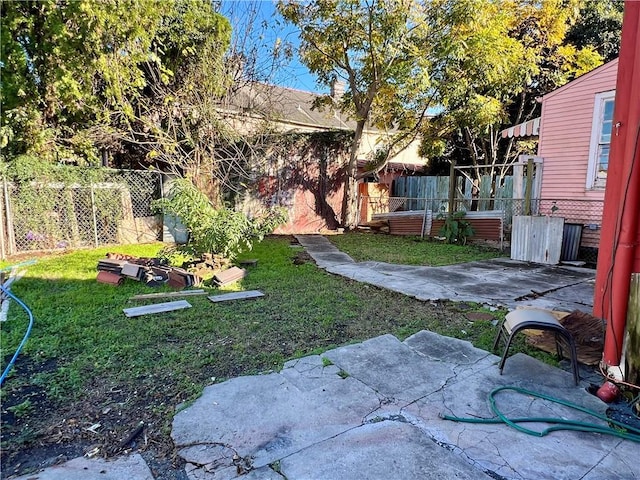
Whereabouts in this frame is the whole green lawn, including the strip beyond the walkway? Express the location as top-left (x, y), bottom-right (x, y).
top-left (0, 234), bottom-right (552, 470)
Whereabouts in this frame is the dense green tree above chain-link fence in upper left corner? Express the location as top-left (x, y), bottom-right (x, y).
top-left (0, 0), bottom-right (162, 161)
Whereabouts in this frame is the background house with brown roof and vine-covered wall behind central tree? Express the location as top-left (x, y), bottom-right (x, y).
top-left (223, 83), bottom-right (425, 233)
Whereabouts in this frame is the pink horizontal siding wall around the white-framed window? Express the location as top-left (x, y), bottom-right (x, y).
top-left (538, 59), bottom-right (618, 200)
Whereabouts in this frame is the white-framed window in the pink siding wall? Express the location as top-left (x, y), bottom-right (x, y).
top-left (587, 90), bottom-right (616, 189)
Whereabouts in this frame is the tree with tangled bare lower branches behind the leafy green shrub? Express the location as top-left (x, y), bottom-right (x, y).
top-left (100, 0), bottom-right (232, 203)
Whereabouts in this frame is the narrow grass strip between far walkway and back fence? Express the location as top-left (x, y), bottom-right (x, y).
top-left (327, 232), bottom-right (504, 267)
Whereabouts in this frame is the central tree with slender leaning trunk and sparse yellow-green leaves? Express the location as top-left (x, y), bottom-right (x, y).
top-left (278, 0), bottom-right (433, 228)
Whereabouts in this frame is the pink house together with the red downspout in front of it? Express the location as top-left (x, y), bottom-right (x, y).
top-left (502, 2), bottom-right (640, 387)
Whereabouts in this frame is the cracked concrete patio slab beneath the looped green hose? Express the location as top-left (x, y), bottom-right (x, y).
top-left (403, 348), bottom-right (640, 479)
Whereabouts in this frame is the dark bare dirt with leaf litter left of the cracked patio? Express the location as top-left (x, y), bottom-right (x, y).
top-left (0, 355), bottom-right (190, 480)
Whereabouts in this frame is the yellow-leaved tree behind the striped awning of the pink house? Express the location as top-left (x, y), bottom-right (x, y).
top-left (423, 0), bottom-right (602, 183)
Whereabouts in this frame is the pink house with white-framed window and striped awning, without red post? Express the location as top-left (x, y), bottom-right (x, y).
top-left (502, 59), bottom-right (618, 261)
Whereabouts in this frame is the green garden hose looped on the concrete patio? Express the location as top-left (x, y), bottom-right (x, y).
top-left (442, 386), bottom-right (640, 442)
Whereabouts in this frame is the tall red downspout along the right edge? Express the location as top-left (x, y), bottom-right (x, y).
top-left (593, 1), bottom-right (640, 367)
